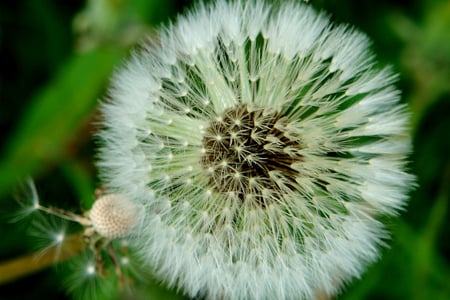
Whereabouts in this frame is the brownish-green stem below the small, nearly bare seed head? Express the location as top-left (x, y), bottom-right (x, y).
top-left (0, 233), bottom-right (87, 285)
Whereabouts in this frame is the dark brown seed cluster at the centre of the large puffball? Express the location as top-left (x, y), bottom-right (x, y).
top-left (201, 104), bottom-right (302, 207)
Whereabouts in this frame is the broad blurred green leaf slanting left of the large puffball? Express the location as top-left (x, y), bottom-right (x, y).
top-left (0, 49), bottom-right (122, 196)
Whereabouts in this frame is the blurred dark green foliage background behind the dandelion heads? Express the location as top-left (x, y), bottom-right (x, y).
top-left (0, 0), bottom-right (450, 299)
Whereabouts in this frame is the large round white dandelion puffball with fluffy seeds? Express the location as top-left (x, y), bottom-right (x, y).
top-left (98, 0), bottom-right (414, 299)
